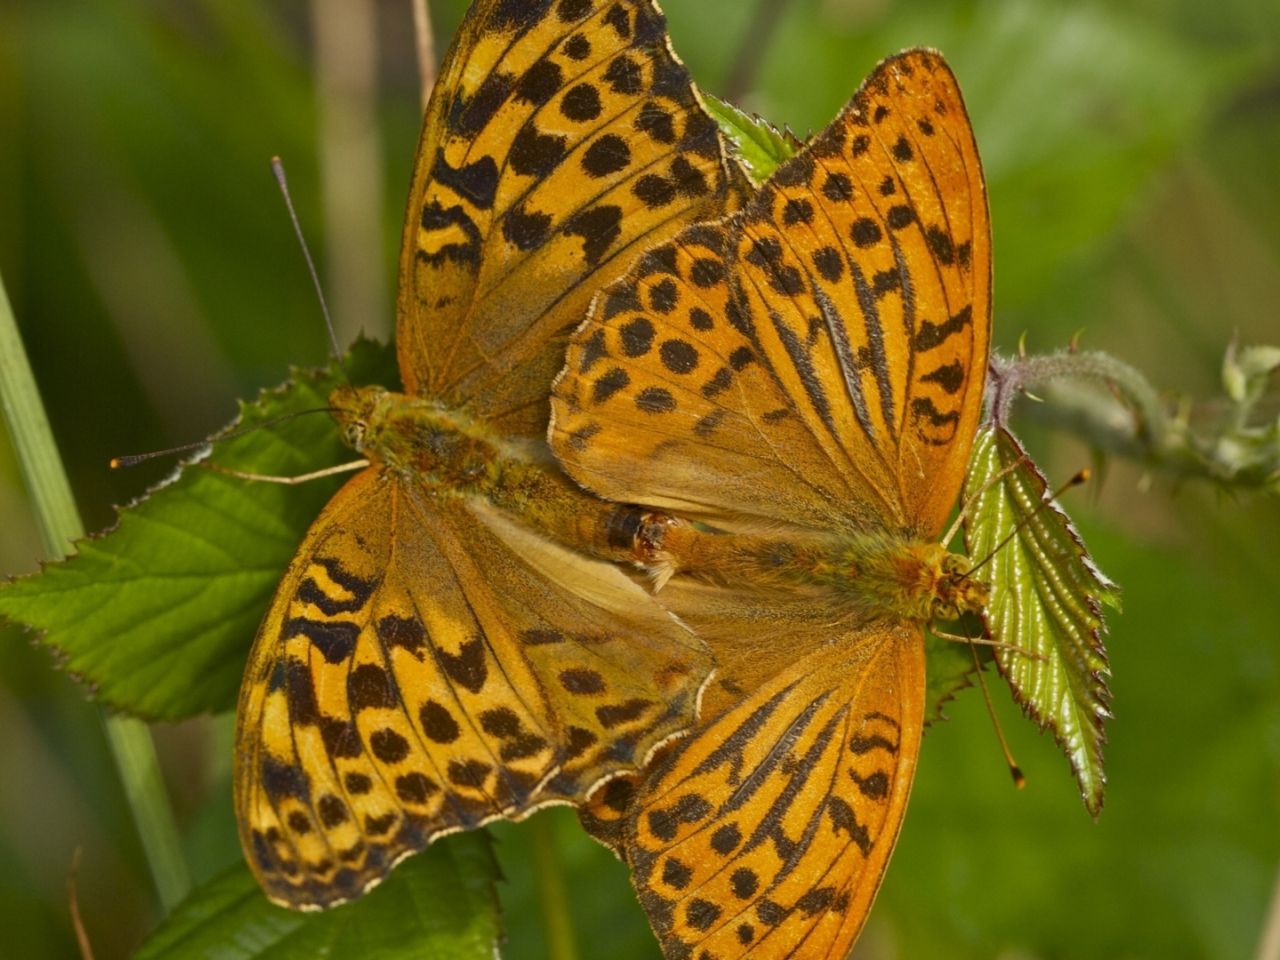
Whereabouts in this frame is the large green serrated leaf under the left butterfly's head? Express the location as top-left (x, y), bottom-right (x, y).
top-left (0, 342), bottom-right (397, 719)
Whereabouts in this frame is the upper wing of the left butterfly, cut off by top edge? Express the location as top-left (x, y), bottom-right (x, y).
top-left (397, 0), bottom-right (745, 435)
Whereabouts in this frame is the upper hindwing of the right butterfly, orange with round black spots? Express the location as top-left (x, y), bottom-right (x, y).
top-left (552, 220), bottom-right (847, 529)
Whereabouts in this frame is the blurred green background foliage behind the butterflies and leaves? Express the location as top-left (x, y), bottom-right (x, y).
top-left (0, 0), bottom-right (1280, 960)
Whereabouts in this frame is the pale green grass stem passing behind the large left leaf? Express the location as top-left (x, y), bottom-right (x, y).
top-left (0, 268), bottom-right (191, 911)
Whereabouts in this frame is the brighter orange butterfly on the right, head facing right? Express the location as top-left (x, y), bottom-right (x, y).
top-left (550, 50), bottom-right (991, 960)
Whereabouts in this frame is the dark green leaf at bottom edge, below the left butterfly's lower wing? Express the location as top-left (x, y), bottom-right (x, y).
top-left (133, 831), bottom-right (502, 960)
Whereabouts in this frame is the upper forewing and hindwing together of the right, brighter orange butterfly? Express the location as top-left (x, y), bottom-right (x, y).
top-left (552, 50), bottom-right (991, 538)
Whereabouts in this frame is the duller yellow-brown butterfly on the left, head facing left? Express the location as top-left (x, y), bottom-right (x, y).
top-left (236, 0), bottom-right (744, 909)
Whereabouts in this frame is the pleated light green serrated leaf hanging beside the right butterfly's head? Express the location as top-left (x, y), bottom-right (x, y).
top-left (965, 426), bottom-right (1120, 817)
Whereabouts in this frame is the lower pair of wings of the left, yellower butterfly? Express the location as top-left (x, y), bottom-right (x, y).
top-left (236, 468), bottom-right (709, 909)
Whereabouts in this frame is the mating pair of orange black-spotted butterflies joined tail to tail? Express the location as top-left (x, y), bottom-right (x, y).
top-left (236, 0), bottom-right (991, 957)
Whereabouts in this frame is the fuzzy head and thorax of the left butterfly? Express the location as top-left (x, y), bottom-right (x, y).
top-left (329, 387), bottom-right (500, 493)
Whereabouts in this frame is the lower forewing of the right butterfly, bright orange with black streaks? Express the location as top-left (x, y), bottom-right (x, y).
top-left (626, 623), bottom-right (924, 960)
